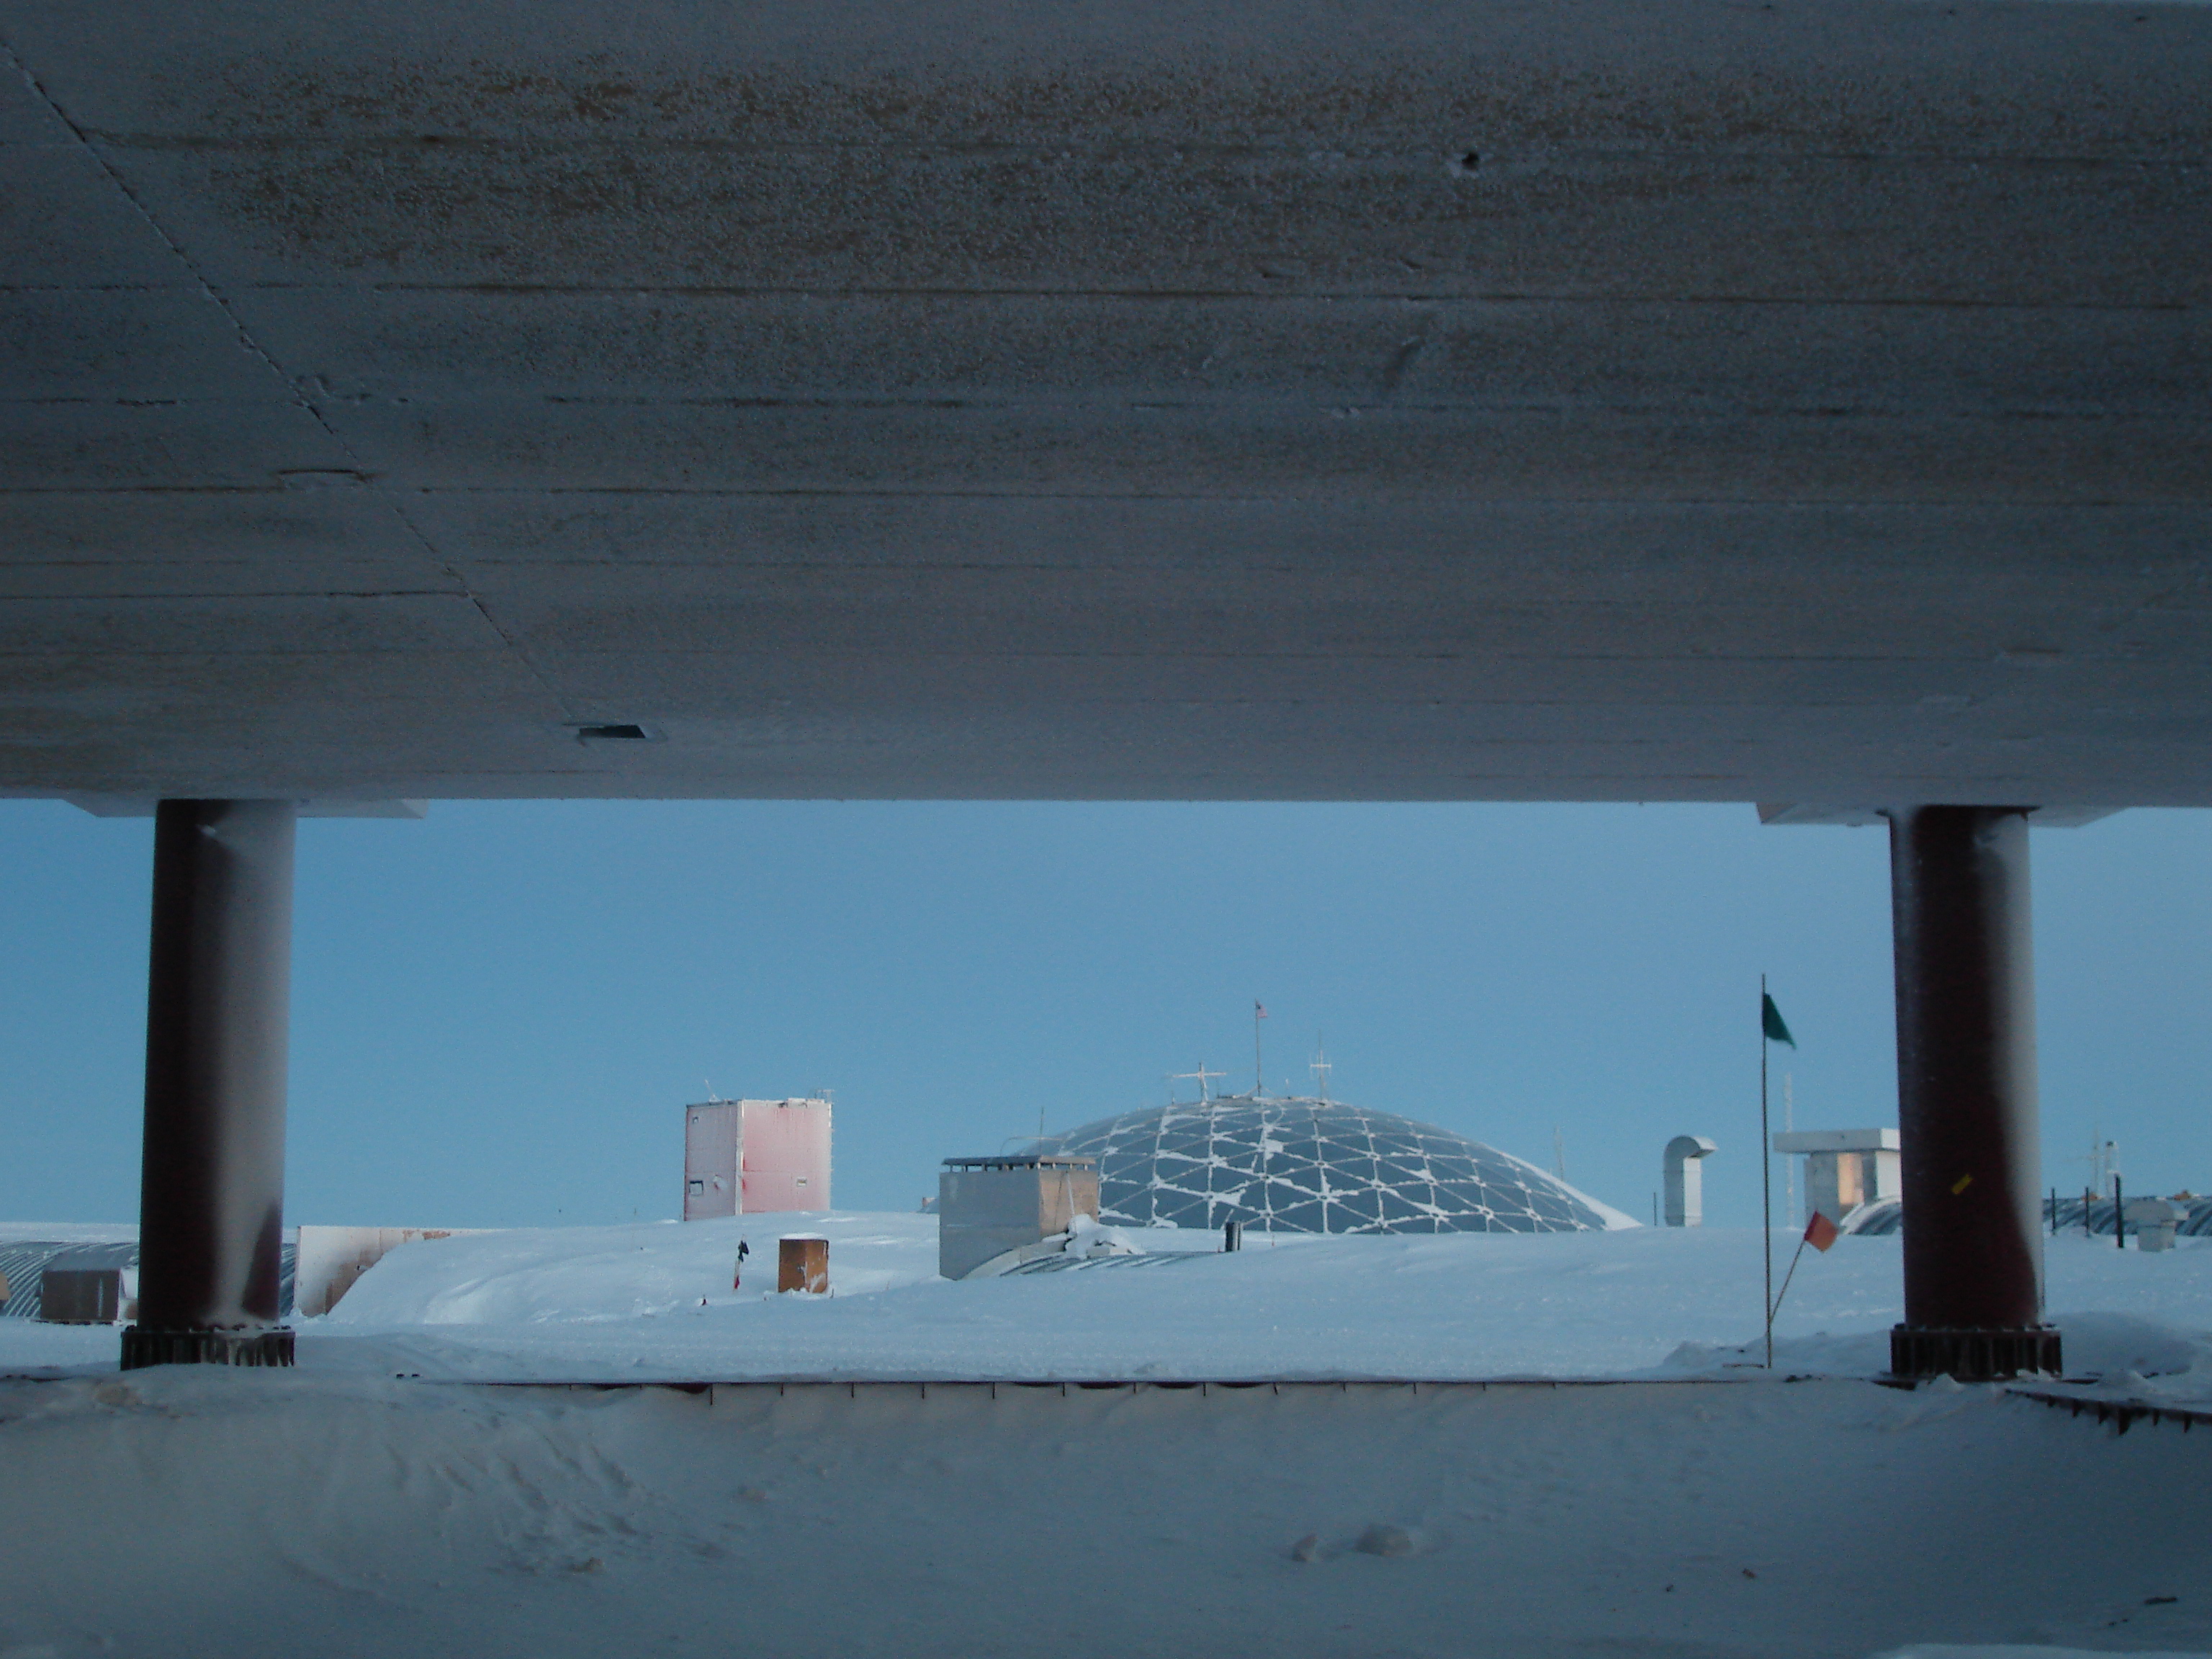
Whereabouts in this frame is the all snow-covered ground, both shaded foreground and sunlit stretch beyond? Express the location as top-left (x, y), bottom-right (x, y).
top-left (0, 1215), bottom-right (2212, 1659)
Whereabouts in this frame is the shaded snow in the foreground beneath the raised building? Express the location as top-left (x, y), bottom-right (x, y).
top-left (0, 1362), bottom-right (2212, 1659)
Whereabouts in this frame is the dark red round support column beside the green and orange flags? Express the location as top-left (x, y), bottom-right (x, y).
top-left (1889, 807), bottom-right (2059, 1378)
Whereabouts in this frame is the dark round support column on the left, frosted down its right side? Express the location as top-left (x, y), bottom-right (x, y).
top-left (124, 801), bottom-right (297, 1372)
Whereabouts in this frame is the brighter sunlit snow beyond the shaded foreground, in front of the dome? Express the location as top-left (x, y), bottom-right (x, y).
top-left (0, 1212), bottom-right (2212, 1405)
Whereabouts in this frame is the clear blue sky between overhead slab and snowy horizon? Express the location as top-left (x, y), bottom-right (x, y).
top-left (0, 801), bottom-right (2212, 1226)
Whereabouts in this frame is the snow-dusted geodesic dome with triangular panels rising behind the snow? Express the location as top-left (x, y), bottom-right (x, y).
top-left (1048, 1095), bottom-right (1608, 1232)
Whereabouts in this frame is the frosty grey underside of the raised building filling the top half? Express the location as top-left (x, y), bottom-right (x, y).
top-left (0, 0), bottom-right (2212, 805)
